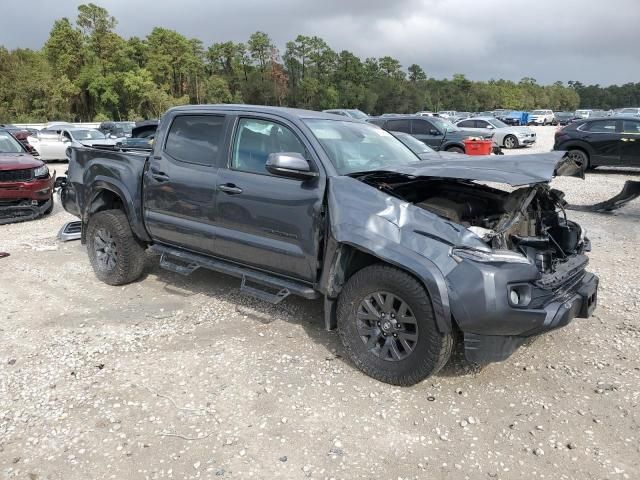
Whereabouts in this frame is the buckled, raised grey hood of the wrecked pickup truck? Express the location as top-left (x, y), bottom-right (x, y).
top-left (368, 151), bottom-right (582, 187)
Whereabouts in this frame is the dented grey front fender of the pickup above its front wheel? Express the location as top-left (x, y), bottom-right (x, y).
top-left (328, 177), bottom-right (487, 332)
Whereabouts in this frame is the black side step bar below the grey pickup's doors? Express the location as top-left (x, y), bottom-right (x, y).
top-left (150, 245), bottom-right (320, 304)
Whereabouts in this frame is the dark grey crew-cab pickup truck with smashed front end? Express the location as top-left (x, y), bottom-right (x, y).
top-left (61, 105), bottom-right (598, 385)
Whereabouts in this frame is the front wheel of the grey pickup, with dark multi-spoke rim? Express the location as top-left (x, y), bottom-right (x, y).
top-left (337, 264), bottom-right (454, 386)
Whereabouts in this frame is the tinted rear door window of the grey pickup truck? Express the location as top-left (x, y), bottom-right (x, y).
top-left (164, 115), bottom-right (225, 166)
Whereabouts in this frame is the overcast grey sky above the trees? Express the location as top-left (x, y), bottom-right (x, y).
top-left (0, 0), bottom-right (640, 85)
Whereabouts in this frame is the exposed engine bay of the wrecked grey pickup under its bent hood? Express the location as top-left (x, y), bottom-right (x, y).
top-left (361, 174), bottom-right (589, 274)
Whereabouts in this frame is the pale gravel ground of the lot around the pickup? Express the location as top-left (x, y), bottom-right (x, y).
top-left (0, 127), bottom-right (640, 480)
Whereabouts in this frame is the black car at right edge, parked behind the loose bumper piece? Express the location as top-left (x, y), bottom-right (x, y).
top-left (553, 117), bottom-right (640, 170)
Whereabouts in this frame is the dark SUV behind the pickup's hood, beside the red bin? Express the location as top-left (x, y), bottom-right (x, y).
top-left (367, 115), bottom-right (490, 153)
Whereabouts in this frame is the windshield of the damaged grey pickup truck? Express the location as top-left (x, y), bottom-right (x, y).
top-left (304, 119), bottom-right (420, 175)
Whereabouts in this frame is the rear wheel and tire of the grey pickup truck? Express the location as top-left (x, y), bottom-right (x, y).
top-left (87, 210), bottom-right (145, 285)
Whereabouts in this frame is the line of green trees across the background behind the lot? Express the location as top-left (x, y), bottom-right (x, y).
top-left (0, 3), bottom-right (640, 123)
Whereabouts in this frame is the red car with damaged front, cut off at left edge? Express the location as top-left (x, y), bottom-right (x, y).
top-left (0, 130), bottom-right (55, 225)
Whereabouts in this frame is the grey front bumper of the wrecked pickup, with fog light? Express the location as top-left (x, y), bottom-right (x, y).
top-left (447, 255), bottom-right (599, 363)
